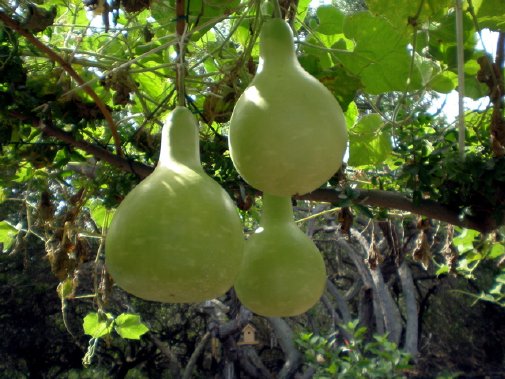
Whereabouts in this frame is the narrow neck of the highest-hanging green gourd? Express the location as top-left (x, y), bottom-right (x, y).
top-left (258, 18), bottom-right (298, 71)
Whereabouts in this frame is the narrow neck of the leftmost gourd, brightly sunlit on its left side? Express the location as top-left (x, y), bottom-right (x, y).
top-left (158, 106), bottom-right (202, 170)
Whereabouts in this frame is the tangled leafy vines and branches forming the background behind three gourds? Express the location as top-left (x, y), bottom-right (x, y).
top-left (0, 0), bottom-right (505, 378)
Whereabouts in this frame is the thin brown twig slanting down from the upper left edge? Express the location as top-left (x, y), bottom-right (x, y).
top-left (0, 11), bottom-right (123, 156)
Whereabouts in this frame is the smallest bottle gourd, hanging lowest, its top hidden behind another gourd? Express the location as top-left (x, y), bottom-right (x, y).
top-left (235, 194), bottom-right (326, 317)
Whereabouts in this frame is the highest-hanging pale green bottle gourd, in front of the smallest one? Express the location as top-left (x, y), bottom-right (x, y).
top-left (229, 19), bottom-right (347, 196)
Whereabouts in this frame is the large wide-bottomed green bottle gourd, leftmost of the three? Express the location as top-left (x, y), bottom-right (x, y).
top-left (105, 107), bottom-right (244, 303)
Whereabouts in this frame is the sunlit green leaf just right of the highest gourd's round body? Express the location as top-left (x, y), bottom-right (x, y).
top-left (349, 113), bottom-right (392, 167)
